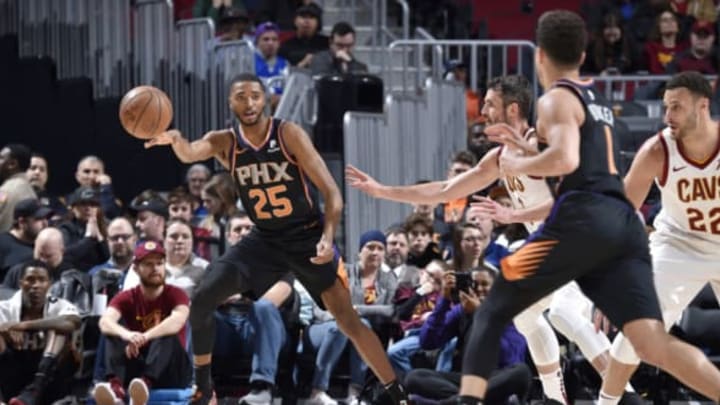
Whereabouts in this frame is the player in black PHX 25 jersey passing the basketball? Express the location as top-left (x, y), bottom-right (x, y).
top-left (145, 74), bottom-right (407, 404)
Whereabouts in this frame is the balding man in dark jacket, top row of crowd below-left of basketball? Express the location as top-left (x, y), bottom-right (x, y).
top-left (68, 155), bottom-right (122, 218)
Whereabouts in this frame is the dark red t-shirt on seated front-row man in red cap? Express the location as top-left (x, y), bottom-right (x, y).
top-left (109, 285), bottom-right (190, 347)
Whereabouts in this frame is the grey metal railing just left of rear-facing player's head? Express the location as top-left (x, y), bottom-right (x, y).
top-left (383, 39), bottom-right (538, 95)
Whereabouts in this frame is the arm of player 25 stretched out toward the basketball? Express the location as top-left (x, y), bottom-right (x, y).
top-left (145, 129), bottom-right (232, 163)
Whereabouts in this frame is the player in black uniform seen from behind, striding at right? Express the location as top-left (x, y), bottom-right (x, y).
top-left (448, 10), bottom-right (720, 405)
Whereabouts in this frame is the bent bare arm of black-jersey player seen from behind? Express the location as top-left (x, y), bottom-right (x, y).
top-left (500, 88), bottom-right (585, 177)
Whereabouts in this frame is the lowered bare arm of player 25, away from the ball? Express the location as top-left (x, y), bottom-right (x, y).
top-left (282, 122), bottom-right (343, 264)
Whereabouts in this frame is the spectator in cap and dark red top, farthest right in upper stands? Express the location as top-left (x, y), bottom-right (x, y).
top-left (666, 20), bottom-right (718, 74)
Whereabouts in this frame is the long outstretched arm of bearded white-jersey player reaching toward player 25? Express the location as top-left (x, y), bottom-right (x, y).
top-left (345, 148), bottom-right (500, 204)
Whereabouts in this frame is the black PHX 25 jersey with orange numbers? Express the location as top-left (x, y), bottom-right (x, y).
top-left (230, 118), bottom-right (322, 231)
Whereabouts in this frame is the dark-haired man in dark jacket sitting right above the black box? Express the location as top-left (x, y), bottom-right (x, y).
top-left (310, 21), bottom-right (367, 75)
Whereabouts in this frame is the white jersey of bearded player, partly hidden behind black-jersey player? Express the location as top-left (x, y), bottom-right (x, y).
top-left (498, 128), bottom-right (552, 233)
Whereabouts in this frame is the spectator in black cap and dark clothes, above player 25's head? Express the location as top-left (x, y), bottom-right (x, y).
top-left (279, 3), bottom-right (329, 68)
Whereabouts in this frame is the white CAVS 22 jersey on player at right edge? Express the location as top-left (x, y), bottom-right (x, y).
top-left (650, 128), bottom-right (720, 258)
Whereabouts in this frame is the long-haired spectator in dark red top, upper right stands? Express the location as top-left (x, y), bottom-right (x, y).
top-left (645, 10), bottom-right (687, 75)
